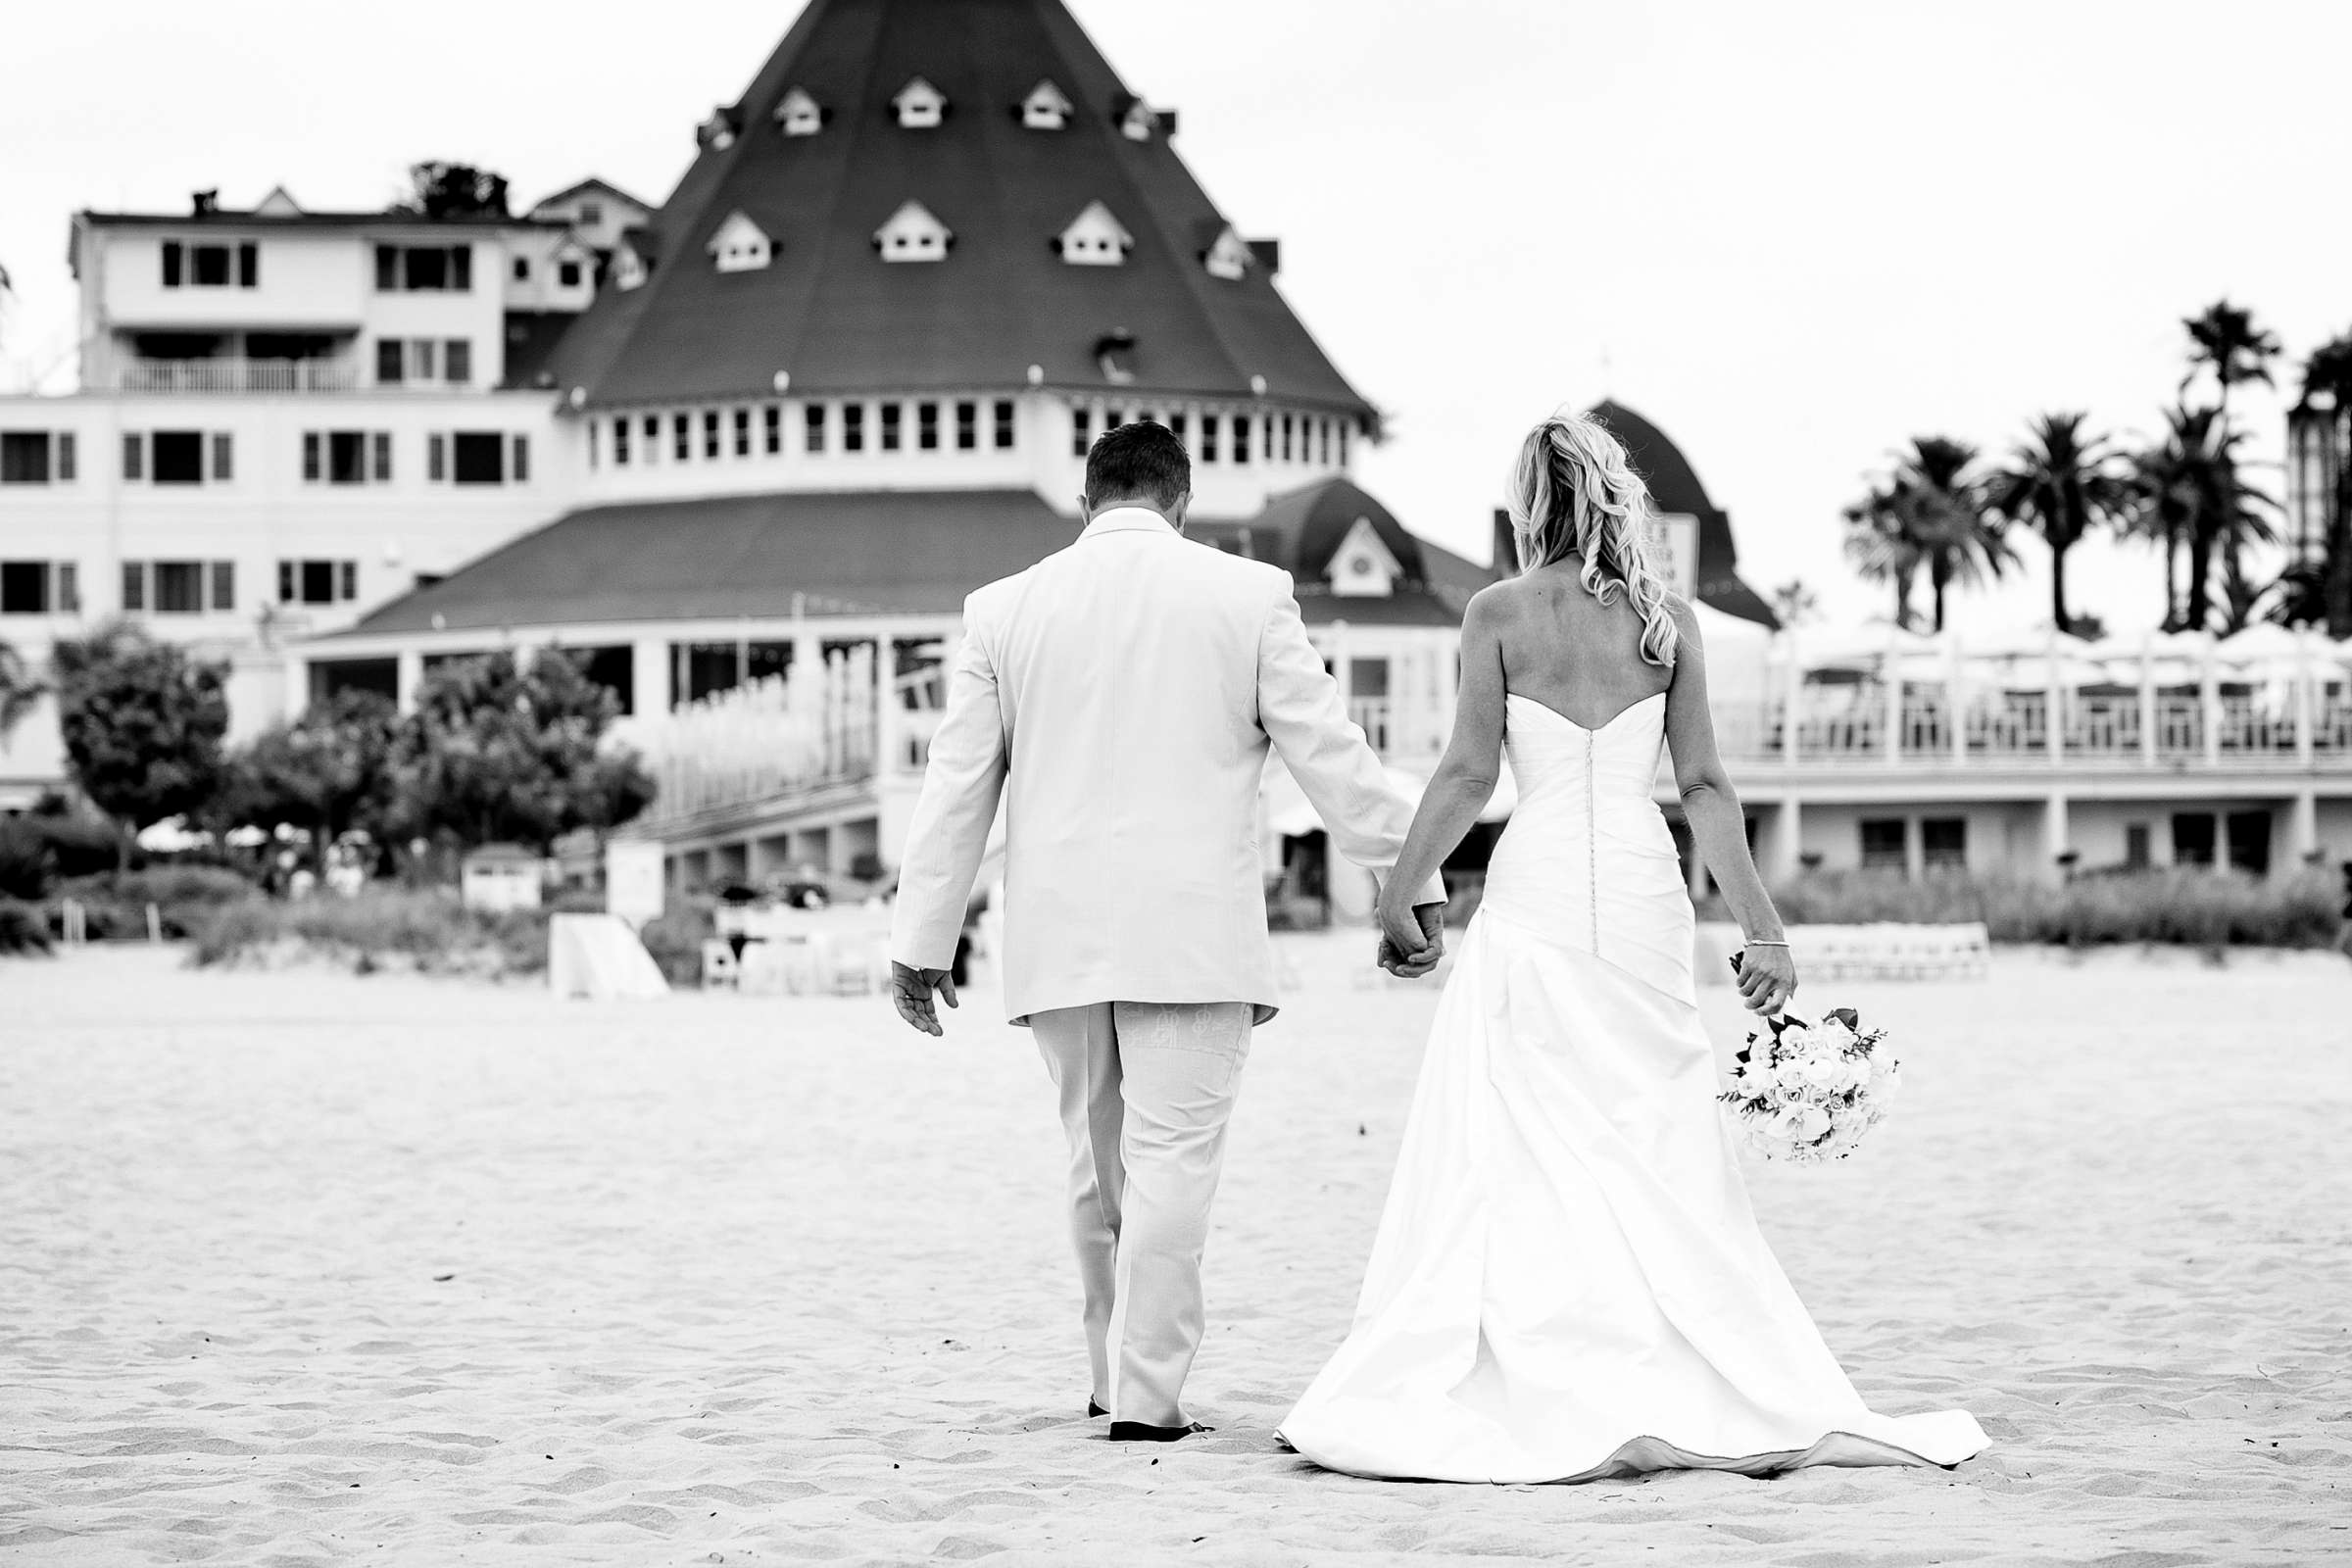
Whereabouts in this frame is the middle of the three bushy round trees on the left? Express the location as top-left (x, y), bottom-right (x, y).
top-left (214, 691), bottom-right (400, 877)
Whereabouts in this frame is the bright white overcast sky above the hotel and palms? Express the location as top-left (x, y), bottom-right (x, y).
top-left (0, 0), bottom-right (2352, 637)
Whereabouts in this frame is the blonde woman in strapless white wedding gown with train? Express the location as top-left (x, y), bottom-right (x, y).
top-left (1282, 416), bottom-right (1985, 1481)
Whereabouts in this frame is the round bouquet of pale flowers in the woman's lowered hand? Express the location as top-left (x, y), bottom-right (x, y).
top-left (1717, 982), bottom-right (1900, 1166)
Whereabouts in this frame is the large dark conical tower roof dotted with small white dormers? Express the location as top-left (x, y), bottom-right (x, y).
top-left (538, 0), bottom-right (1374, 418)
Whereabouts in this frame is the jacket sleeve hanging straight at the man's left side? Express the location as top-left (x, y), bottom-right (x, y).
top-left (889, 600), bottom-right (1004, 968)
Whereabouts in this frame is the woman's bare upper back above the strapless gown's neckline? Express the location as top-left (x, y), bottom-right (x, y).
top-left (1500, 555), bottom-right (1675, 729)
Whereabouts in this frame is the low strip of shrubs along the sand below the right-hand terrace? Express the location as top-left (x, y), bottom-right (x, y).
top-left (1700, 867), bottom-right (2342, 948)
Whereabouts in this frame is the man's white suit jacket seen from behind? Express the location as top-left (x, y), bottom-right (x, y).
top-left (892, 508), bottom-right (1445, 1022)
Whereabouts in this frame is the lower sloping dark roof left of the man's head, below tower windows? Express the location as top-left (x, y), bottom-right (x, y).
top-left (329, 489), bottom-right (1077, 642)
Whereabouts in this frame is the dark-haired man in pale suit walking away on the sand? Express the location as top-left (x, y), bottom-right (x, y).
top-left (892, 423), bottom-right (1445, 1444)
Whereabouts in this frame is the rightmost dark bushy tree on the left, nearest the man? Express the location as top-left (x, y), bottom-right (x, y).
top-left (390, 649), bottom-right (654, 851)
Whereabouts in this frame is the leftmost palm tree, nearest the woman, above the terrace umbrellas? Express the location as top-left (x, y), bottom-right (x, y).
top-left (1846, 435), bottom-right (2018, 632)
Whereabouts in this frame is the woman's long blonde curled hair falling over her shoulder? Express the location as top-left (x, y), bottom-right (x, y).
top-left (1510, 412), bottom-right (1680, 667)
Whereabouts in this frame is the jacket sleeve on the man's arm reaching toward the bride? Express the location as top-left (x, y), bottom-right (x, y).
top-left (1258, 576), bottom-right (1446, 906)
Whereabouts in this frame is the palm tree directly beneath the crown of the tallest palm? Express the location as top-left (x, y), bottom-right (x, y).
top-left (2133, 409), bottom-right (2277, 630)
